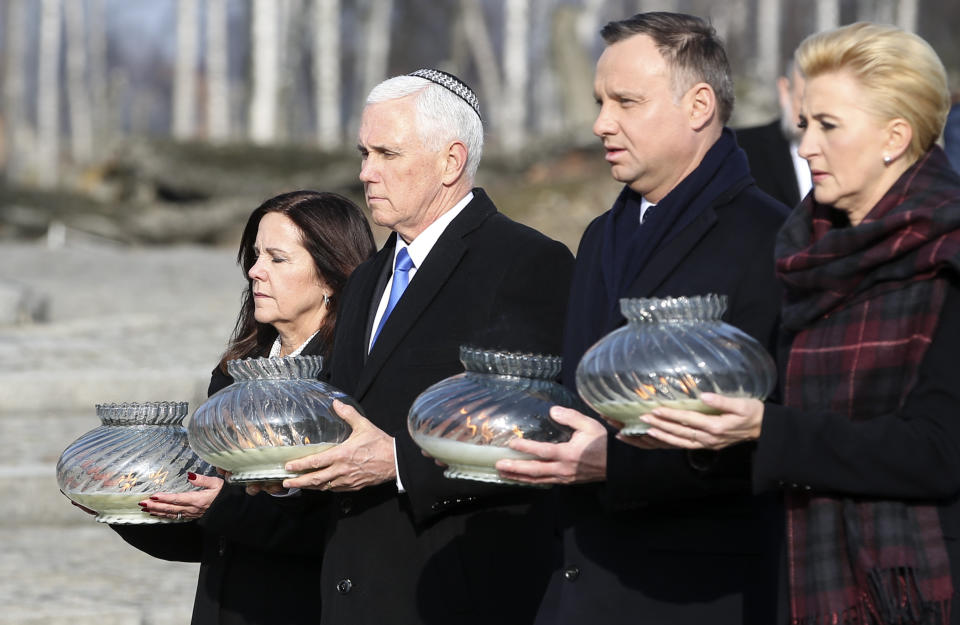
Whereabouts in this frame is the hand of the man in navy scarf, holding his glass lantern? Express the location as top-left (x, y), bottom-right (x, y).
top-left (496, 406), bottom-right (607, 484)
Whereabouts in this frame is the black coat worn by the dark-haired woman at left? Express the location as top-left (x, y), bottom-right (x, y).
top-left (111, 339), bottom-right (327, 625)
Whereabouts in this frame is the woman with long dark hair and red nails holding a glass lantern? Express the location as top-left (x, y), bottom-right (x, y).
top-left (112, 191), bottom-right (375, 625)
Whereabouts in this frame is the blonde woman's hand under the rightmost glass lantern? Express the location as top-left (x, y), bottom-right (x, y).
top-left (617, 393), bottom-right (763, 449)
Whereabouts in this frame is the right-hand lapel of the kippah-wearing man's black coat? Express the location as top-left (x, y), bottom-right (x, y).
top-left (355, 189), bottom-right (496, 399)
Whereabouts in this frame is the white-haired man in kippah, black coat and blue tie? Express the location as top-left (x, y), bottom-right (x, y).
top-left (278, 70), bottom-right (573, 625)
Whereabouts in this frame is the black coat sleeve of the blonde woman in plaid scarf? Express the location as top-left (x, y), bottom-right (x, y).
top-left (753, 286), bottom-right (960, 499)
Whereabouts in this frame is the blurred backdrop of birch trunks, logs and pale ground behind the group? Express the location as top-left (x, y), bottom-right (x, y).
top-left (0, 0), bottom-right (960, 625)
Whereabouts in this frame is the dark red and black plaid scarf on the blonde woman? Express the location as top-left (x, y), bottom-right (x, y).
top-left (776, 147), bottom-right (960, 625)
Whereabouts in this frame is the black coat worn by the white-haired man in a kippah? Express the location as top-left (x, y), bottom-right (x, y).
top-left (315, 189), bottom-right (573, 625)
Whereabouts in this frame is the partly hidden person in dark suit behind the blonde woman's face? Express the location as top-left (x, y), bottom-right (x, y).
top-left (736, 61), bottom-right (813, 208)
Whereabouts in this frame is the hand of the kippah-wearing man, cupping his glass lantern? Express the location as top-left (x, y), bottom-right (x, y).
top-left (283, 400), bottom-right (397, 491)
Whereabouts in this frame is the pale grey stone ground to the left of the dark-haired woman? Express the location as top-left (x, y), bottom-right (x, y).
top-left (0, 238), bottom-right (243, 625)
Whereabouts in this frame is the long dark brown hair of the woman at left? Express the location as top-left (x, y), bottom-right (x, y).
top-left (220, 191), bottom-right (376, 372)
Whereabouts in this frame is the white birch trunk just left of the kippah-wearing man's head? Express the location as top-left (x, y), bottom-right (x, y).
top-left (313, 0), bottom-right (342, 150)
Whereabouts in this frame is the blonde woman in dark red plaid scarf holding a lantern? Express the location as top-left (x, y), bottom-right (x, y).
top-left (645, 23), bottom-right (960, 625)
